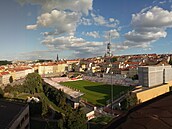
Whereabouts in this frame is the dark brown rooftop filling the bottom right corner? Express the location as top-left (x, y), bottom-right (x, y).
top-left (106, 93), bottom-right (172, 129)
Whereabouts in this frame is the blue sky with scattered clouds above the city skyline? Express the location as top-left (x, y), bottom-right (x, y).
top-left (0, 0), bottom-right (172, 60)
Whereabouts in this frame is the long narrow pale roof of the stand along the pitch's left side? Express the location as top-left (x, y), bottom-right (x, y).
top-left (44, 78), bottom-right (84, 98)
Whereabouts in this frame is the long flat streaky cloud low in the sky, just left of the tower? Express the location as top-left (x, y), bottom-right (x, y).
top-left (42, 36), bottom-right (105, 57)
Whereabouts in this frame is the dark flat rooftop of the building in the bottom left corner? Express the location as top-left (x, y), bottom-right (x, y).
top-left (0, 99), bottom-right (27, 129)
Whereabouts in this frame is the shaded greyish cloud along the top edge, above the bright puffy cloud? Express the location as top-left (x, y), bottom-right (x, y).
top-left (18, 0), bottom-right (93, 15)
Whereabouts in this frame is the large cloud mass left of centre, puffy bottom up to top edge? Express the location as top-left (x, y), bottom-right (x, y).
top-left (21, 0), bottom-right (93, 36)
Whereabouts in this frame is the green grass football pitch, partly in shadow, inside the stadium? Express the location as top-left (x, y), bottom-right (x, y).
top-left (60, 80), bottom-right (129, 106)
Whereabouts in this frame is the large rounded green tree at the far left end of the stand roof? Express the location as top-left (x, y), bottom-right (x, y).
top-left (24, 73), bottom-right (43, 94)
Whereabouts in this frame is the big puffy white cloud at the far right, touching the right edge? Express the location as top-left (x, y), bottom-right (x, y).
top-left (122, 6), bottom-right (172, 48)
